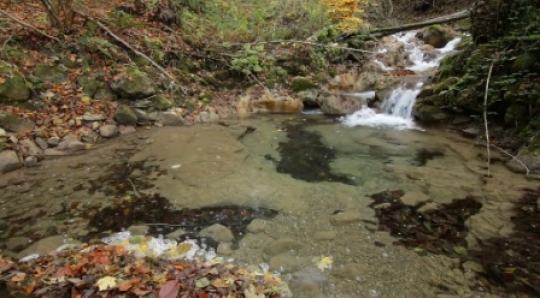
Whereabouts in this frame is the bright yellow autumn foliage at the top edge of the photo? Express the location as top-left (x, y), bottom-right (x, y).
top-left (321, 0), bottom-right (367, 31)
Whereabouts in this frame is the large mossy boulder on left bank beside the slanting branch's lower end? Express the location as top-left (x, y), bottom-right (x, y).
top-left (111, 70), bottom-right (156, 100)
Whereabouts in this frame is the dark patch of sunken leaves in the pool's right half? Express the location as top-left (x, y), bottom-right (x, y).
top-left (369, 190), bottom-right (482, 257)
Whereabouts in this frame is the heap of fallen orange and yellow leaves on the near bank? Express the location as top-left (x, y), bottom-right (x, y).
top-left (0, 245), bottom-right (283, 298)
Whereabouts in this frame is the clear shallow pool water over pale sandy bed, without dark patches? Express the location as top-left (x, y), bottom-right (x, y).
top-left (0, 115), bottom-right (531, 298)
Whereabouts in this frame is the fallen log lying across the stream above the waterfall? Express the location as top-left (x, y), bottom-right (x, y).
top-left (343, 9), bottom-right (471, 39)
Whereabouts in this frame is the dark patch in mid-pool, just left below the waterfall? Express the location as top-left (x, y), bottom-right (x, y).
top-left (265, 119), bottom-right (356, 185)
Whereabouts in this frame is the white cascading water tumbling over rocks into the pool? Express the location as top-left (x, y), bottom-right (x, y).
top-left (340, 31), bottom-right (461, 130)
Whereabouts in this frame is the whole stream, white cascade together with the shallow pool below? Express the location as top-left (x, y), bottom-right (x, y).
top-left (0, 33), bottom-right (536, 298)
